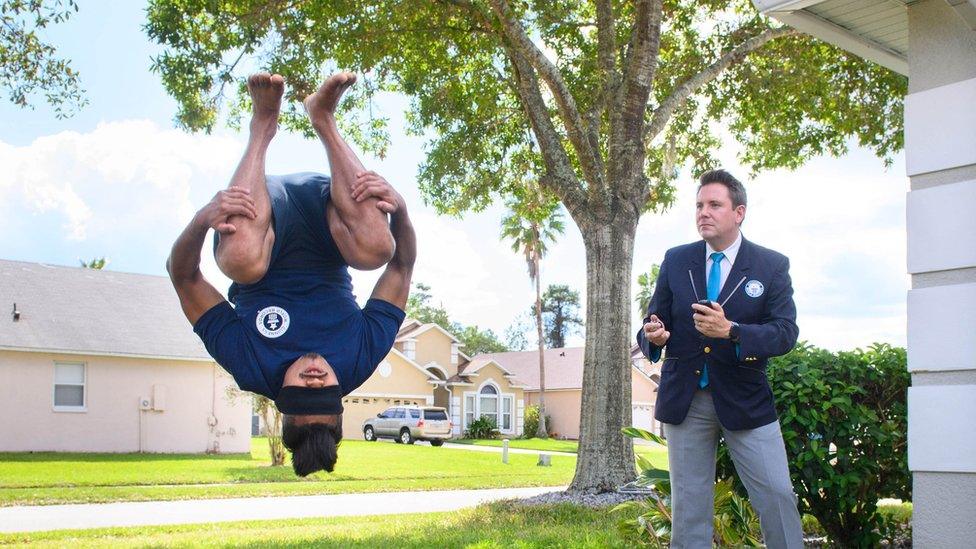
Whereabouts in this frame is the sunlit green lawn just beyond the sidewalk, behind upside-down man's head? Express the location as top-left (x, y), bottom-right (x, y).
top-left (0, 438), bottom-right (576, 506)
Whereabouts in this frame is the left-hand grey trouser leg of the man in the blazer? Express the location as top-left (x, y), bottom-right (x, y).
top-left (664, 391), bottom-right (721, 549)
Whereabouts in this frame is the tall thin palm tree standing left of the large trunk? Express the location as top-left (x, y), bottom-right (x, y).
top-left (502, 184), bottom-right (564, 438)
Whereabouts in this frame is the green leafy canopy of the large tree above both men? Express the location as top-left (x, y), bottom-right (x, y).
top-left (145, 0), bottom-right (906, 218)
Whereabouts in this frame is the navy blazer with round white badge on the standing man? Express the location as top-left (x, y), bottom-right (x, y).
top-left (637, 238), bottom-right (799, 430)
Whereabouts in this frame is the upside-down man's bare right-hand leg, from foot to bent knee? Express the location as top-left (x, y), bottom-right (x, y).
top-left (305, 72), bottom-right (394, 270)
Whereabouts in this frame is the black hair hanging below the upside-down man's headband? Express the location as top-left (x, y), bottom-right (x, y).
top-left (281, 414), bottom-right (342, 477)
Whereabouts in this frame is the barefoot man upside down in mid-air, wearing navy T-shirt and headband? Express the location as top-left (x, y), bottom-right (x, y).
top-left (167, 73), bottom-right (417, 476)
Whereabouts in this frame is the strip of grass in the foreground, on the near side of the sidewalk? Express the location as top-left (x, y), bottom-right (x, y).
top-left (0, 502), bottom-right (630, 549)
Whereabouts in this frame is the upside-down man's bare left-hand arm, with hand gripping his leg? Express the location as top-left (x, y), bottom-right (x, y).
top-left (166, 187), bottom-right (257, 324)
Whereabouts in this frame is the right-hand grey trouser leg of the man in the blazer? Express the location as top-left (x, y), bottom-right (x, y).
top-left (723, 421), bottom-right (803, 549)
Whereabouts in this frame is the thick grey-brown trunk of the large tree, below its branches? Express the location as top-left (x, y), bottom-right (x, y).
top-left (569, 212), bottom-right (637, 493)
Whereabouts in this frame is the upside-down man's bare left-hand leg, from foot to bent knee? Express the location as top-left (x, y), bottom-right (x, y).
top-left (216, 73), bottom-right (285, 284)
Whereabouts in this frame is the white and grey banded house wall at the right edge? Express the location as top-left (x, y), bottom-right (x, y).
top-left (905, 0), bottom-right (976, 548)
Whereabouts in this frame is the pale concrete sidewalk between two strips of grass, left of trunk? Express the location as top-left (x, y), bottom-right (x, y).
top-left (0, 486), bottom-right (566, 532)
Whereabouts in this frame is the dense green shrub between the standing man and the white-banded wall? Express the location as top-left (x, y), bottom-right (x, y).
top-left (719, 344), bottom-right (912, 547)
